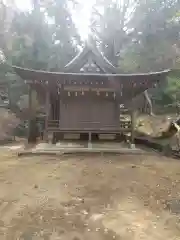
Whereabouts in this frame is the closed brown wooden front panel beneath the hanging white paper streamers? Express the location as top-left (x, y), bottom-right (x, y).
top-left (60, 98), bottom-right (119, 130)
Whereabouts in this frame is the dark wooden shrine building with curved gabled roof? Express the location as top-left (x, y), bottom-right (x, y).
top-left (13, 41), bottom-right (169, 144)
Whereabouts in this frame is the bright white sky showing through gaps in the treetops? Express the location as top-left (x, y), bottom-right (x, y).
top-left (15, 0), bottom-right (96, 40)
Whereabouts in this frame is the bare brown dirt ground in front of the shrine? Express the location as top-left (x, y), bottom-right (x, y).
top-left (0, 150), bottom-right (180, 240)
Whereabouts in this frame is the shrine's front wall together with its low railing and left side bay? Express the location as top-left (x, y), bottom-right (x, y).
top-left (48, 93), bottom-right (120, 132)
